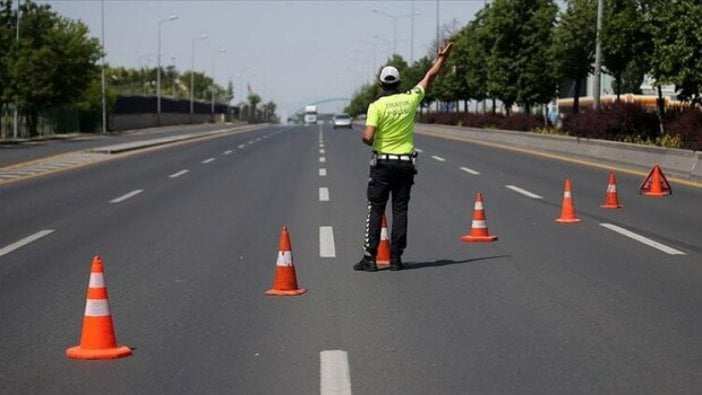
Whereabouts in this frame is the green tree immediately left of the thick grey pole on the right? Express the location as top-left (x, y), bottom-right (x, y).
top-left (553, 0), bottom-right (597, 113)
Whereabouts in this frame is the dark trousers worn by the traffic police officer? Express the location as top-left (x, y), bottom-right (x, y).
top-left (363, 159), bottom-right (417, 258)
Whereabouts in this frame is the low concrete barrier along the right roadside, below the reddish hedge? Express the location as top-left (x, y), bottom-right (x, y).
top-left (415, 124), bottom-right (702, 181)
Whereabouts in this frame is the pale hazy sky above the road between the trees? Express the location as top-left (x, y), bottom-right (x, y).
top-left (38, 0), bottom-right (485, 117)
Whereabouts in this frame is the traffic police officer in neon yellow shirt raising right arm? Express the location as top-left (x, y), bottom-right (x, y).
top-left (353, 43), bottom-right (452, 272)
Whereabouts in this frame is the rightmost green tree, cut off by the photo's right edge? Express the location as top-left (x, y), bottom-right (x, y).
top-left (649, 0), bottom-right (702, 104)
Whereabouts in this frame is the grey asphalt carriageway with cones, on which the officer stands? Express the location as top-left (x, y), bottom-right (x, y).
top-left (0, 126), bottom-right (702, 394)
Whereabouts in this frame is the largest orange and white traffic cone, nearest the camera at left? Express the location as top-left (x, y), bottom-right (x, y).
top-left (66, 256), bottom-right (132, 359)
